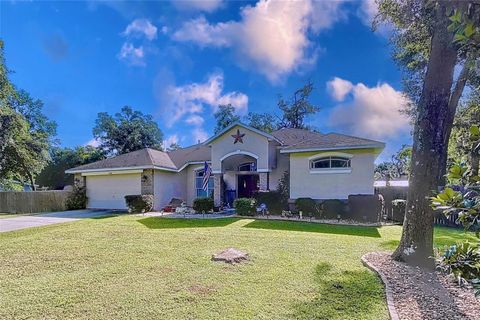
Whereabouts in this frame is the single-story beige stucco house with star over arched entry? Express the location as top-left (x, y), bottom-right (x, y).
top-left (66, 122), bottom-right (385, 210)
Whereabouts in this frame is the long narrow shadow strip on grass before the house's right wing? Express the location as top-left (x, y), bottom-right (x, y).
top-left (244, 220), bottom-right (380, 238)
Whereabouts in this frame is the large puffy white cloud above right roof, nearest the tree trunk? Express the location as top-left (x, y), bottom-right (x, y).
top-left (330, 78), bottom-right (410, 139)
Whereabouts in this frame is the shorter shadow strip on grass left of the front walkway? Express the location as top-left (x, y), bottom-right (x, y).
top-left (138, 217), bottom-right (240, 229)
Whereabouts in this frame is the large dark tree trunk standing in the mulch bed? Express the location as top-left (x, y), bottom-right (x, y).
top-left (393, 2), bottom-right (457, 268)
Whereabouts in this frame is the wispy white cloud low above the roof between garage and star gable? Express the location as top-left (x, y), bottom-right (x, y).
top-left (162, 72), bottom-right (248, 127)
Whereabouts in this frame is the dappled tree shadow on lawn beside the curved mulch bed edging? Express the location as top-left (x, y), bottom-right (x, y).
top-left (292, 263), bottom-right (387, 319)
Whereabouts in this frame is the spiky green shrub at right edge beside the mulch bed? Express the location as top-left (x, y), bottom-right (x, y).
top-left (438, 242), bottom-right (480, 294)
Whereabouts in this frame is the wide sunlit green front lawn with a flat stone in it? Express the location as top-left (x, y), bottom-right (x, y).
top-left (0, 216), bottom-right (474, 319)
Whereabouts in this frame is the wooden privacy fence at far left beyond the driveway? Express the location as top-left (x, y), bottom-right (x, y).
top-left (0, 190), bottom-right (71, 213)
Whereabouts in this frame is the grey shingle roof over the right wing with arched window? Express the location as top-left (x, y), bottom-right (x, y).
top-left (272, 128), bottom-right (385, 152)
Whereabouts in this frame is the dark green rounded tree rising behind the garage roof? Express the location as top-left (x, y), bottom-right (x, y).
top-left (93, 106), bottom-right (163, 155)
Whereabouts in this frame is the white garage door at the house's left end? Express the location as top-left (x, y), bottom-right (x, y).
top-left (87, 173), bottom-right (141, 209)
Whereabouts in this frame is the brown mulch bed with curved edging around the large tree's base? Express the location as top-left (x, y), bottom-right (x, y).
top-left (362, 252), bottom-right (480, 320)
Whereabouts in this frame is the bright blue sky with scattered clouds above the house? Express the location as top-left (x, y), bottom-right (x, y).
top-left (0, 0), bottom-right (411, 159)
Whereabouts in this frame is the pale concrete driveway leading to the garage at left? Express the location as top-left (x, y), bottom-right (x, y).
top-left (0, 209), bottom-right (114, 232)
